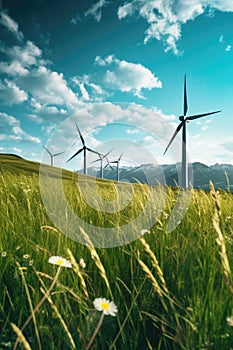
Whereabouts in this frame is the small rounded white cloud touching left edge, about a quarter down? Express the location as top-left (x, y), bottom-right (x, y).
top-left (0, 79), bottom-right (28, 105)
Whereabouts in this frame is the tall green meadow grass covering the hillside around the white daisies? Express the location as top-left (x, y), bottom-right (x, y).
top-left (0, 155), bottom-right (233, 350)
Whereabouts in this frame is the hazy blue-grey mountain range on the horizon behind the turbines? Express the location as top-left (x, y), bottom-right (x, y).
top-left (85, 162), bottom-right (233, 192)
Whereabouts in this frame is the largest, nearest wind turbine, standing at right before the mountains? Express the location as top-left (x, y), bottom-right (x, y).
top-left (164, 74), bottom-right (221, 188)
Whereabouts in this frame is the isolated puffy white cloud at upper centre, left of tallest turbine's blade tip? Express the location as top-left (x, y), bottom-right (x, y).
top-left (95, 55), bottom-right (162, 98)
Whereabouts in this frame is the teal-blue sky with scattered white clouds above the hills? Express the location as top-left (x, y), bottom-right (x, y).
top-left (0, 0), bottom-right (233, 170)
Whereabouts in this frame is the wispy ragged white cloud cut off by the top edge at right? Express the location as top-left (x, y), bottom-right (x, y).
top-left (118, 0), bottom-right (233, 54)
